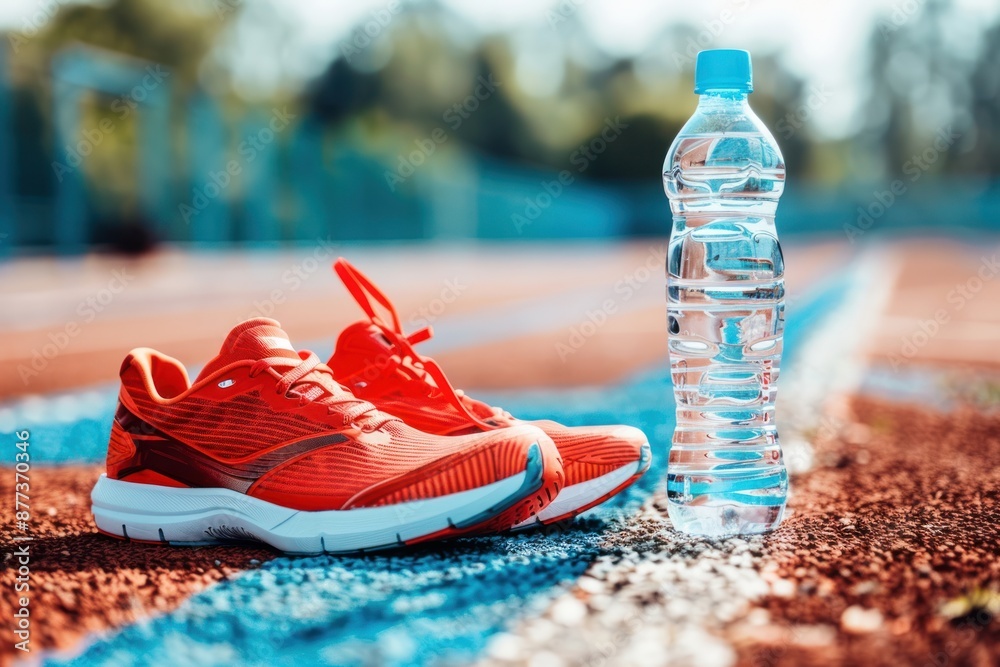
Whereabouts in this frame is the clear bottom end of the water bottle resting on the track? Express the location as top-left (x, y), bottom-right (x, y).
top-left (667, 501), bottom-right (785, 537)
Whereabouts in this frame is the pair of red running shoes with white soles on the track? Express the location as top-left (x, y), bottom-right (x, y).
top-left (91, 259), bottom-right (650, 554)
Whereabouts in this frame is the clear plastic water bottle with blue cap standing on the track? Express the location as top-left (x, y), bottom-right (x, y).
top-left (663, 49), bottom-right (788, 535)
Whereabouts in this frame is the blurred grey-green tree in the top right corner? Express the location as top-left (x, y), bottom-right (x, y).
top-left (854, 0), bottom-right (1000, 178)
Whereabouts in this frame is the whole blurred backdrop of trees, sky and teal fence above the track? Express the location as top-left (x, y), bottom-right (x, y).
top-left (0, 0), bottom-right (1000, 254)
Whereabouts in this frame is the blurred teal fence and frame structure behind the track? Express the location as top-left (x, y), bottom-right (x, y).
top-left (0, 46), bottom-right (1000, 256)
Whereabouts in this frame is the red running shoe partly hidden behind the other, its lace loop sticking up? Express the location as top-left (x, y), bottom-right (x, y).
top-left (328, 258), bottom-right (652, 528)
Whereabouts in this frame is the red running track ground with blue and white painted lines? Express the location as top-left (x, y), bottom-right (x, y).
top-left (0, 242), bottom-right (1000, 665)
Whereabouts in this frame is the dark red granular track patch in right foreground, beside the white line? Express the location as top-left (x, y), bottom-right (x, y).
top-left (729, 399), bottom-right (1000, 667)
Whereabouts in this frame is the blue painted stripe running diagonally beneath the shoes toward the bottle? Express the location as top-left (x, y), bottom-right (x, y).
top-left (37, 280), bottom-right (847, 667)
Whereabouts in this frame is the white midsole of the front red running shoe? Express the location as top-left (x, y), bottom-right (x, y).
top-left (91, 472), bottom-right (527, 554)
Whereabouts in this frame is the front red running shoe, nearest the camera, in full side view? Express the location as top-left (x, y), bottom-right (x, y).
top-left (91, 319), bottom-right (562, 554)
